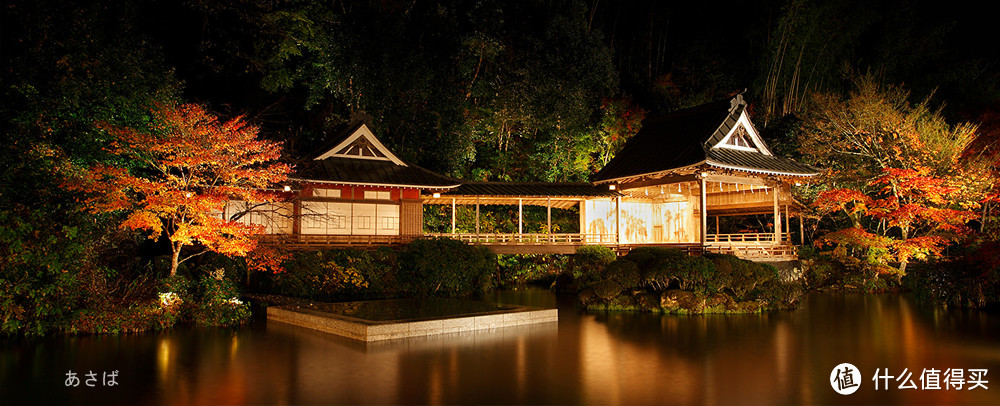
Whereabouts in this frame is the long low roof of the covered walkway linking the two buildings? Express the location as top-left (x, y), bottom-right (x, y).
top-left (442, 182), bottom-right (618, 197)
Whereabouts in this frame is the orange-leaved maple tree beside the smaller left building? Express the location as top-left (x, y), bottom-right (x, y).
top-left (78, 104), bottom-right (291, 276)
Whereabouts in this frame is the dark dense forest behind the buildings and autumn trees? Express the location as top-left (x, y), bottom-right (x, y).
top-left (0, 0), bottom-right (1000, 331)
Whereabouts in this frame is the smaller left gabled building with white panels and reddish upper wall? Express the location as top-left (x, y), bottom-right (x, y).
top-left (251, 123), bottom-right (460, 246)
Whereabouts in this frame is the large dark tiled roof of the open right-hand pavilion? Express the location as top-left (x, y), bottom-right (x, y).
top-left (593, 95), bottom-right (816, 182)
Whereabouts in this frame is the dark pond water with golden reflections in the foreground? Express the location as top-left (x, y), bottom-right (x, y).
top-left (0, 290), bottom-right (1000, 405)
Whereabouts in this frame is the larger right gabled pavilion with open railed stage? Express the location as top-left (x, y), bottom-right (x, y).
top-left (581, 95), bottom-right (817, 258)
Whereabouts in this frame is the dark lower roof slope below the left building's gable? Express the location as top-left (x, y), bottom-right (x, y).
top-left (297, 157), bottom-right (461, 189)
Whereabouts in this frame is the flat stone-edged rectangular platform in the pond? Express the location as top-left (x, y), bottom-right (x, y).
top-left (267, 298), bottom-right (559, 341)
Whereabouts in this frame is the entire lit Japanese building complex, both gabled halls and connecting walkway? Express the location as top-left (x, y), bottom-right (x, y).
top-left (256, 95), bottom-right (817, 260)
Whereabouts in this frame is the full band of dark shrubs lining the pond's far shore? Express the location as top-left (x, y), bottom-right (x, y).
top-left (47, 238), bottom-right (997, 334)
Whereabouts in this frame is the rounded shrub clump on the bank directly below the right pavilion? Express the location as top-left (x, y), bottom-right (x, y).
top-left (572, 246), bottom-right (803, 314)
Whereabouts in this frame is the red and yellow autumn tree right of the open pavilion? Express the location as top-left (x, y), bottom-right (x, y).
top-left (800, 76), bottom-right (993, 275)
